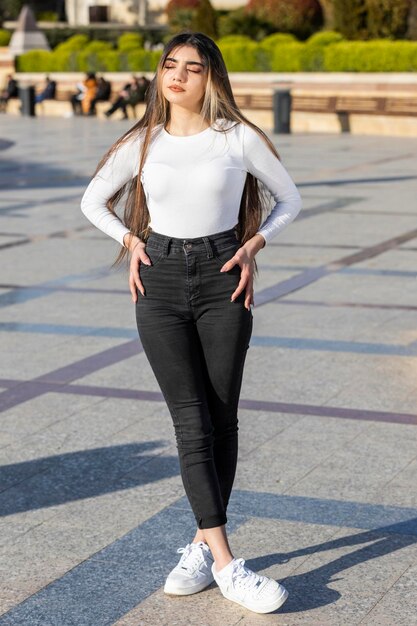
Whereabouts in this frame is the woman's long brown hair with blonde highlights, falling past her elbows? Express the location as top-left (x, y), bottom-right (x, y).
top-left (96, 32), bottom-right (279, 264)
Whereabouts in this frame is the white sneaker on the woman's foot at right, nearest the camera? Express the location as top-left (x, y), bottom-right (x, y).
top-left (211, 559), bottom-right (288, 613)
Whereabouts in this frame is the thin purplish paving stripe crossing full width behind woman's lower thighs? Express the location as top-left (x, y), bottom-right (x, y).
top-left (0, 378), bottom-right (417, 430)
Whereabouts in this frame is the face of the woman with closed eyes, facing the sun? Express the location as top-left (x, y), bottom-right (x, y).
top-left (162, 46), bottom-right (207, 112)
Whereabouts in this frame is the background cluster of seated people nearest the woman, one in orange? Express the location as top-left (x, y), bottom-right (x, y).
top-left (70, 73), bottom-right (150, 119)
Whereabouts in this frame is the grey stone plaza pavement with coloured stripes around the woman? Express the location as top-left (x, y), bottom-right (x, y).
top-left (0, 116), bottom-right (417, 626)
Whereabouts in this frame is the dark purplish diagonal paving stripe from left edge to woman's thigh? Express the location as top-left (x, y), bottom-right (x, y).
top-left (0, 340), bottom-right (142, 413)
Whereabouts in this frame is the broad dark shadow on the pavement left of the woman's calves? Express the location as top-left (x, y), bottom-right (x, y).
top-left (0, 441), bottom-right (179, 517)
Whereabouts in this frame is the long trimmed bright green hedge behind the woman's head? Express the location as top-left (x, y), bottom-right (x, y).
top-left (17, 31), bottom-right (417, 72)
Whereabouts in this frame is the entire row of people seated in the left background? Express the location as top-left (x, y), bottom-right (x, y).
top-left (0, 72), bottom-right (150, 119)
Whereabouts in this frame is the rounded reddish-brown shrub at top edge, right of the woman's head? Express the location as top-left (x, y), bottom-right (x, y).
top-left (246, 0), bottom-right (323, 39)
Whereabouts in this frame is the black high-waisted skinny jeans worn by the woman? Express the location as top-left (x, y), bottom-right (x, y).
top-left (136, 230), bottom-right (252, 528)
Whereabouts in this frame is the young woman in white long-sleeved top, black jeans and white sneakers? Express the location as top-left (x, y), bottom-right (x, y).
top-left (82, 33), bottom-right (300, 613)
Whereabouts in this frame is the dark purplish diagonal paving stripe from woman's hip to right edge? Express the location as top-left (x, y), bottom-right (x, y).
top-left (255, 228), bottom-right (417, 306)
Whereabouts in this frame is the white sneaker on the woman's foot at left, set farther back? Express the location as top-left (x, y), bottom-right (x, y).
top-left (164, 541), bottom-right (214, 596)
